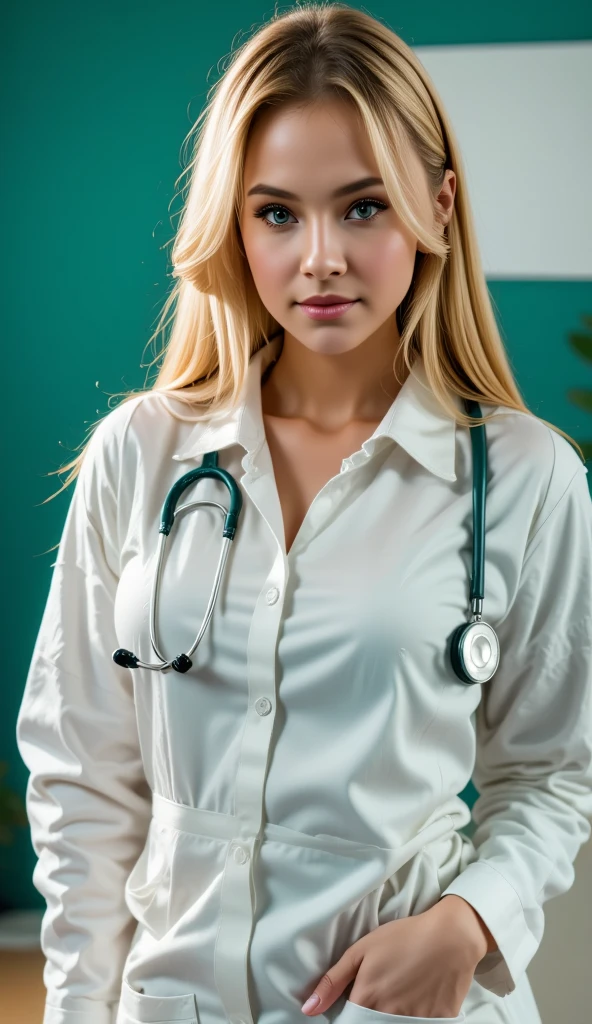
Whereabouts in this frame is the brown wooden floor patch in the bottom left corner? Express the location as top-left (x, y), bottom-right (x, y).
top-left (0, 949), bottom-right (45, 1024)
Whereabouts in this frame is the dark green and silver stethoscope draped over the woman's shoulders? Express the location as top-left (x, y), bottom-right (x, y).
top-left (113, 398), bottom-right (500, 685)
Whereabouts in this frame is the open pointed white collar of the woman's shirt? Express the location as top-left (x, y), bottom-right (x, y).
top-left (167, 334), bottom-right (462, 481)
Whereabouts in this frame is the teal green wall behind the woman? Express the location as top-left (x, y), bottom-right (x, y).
top-left (0, 0), bottom-right (592, 909)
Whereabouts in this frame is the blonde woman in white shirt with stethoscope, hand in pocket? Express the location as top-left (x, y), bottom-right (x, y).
top-left (17, 4), bottom-right (592, 1024)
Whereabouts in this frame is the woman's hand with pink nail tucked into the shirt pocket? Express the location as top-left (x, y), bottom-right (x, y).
top-left (302, 894), bottom-right (491, 1017)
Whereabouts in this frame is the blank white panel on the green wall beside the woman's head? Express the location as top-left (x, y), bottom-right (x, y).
top-left (415, 41), bottom-right (592, 281)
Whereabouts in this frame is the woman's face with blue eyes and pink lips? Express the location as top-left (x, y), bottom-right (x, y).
top-left (240, 99), bottom-right (452, 353)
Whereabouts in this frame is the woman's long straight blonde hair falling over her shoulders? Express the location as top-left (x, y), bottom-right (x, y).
top-left (42, 2), bottom-right (585, 504)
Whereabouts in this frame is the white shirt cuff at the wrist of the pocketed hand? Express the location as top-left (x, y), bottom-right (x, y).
top-left (440, 860), bottom-right (539, 995)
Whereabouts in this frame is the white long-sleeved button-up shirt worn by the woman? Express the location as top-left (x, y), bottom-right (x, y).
top-left (17, 329), bottom-right (592, 1024)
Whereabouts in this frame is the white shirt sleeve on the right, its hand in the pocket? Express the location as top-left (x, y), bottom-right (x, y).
top-left (440, 462), bottom-right (592, 995)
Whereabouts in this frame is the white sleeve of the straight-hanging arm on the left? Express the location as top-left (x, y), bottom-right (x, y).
top-left (16, 407), bottom-right (152, 1024)
